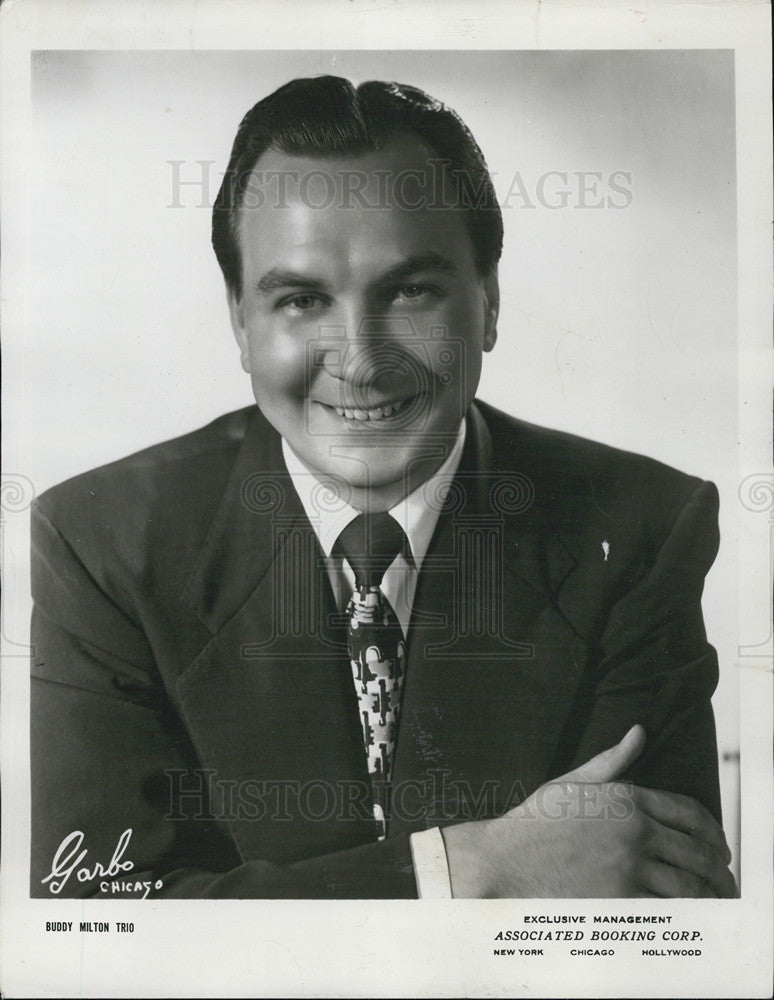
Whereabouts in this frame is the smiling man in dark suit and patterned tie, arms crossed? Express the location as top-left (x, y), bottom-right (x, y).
top-left (27, 77), bottom-right (735, 898)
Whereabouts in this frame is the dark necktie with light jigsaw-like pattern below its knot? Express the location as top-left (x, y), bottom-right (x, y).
top-left (334, 513), bottom-right (416, 840)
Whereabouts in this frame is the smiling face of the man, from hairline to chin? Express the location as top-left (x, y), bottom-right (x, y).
top-left (229, 134), bottom-right (498, 506)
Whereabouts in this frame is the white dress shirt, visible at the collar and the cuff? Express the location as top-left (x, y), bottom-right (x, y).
top-left (282, 420), bottom-right (466, 899)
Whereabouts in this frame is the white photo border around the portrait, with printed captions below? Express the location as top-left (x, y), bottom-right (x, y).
top-left (0, 0), bottom-right (774, 997)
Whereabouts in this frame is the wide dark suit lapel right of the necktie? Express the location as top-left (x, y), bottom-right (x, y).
top-left (391, 407), bottom-right (586, 833)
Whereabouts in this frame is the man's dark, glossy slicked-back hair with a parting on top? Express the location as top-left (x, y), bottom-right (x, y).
top-left (212, 76), bottom-right (503, 296)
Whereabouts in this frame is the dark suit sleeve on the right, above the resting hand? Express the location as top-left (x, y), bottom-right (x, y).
top-left (566, 483), bottom-right (720, 821)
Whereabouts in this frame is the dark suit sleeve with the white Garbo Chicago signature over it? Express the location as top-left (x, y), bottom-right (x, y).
top-left (30, 507), bottom-right (416, 899)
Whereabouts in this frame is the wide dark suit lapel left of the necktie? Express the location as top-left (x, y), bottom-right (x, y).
top-left (177, 420), bottom-right (378, 862)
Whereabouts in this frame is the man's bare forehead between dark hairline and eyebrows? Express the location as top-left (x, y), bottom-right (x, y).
top-left (233, 134), bottom-right (473, 273)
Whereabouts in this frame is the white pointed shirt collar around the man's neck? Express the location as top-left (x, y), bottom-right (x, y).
top-left (282, 420), bottom-right (466, 571)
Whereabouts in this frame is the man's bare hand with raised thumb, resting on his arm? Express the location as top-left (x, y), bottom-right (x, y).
top-left (443, 726), bottom-right (736, 899)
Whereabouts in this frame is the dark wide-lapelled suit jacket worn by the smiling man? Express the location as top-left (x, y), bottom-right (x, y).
top-left (32, 403), bottom-right (719, 898)
